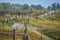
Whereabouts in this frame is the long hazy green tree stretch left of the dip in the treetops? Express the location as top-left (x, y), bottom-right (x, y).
top-left (0, 3), bottom-right (43, 10)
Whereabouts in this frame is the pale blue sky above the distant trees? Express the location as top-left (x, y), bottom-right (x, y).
top-left (0, 0), bottom-right (60, 7)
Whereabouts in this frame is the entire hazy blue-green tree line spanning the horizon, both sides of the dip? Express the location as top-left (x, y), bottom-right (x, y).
top-left (0, 3), bottom-right (60, 10)
